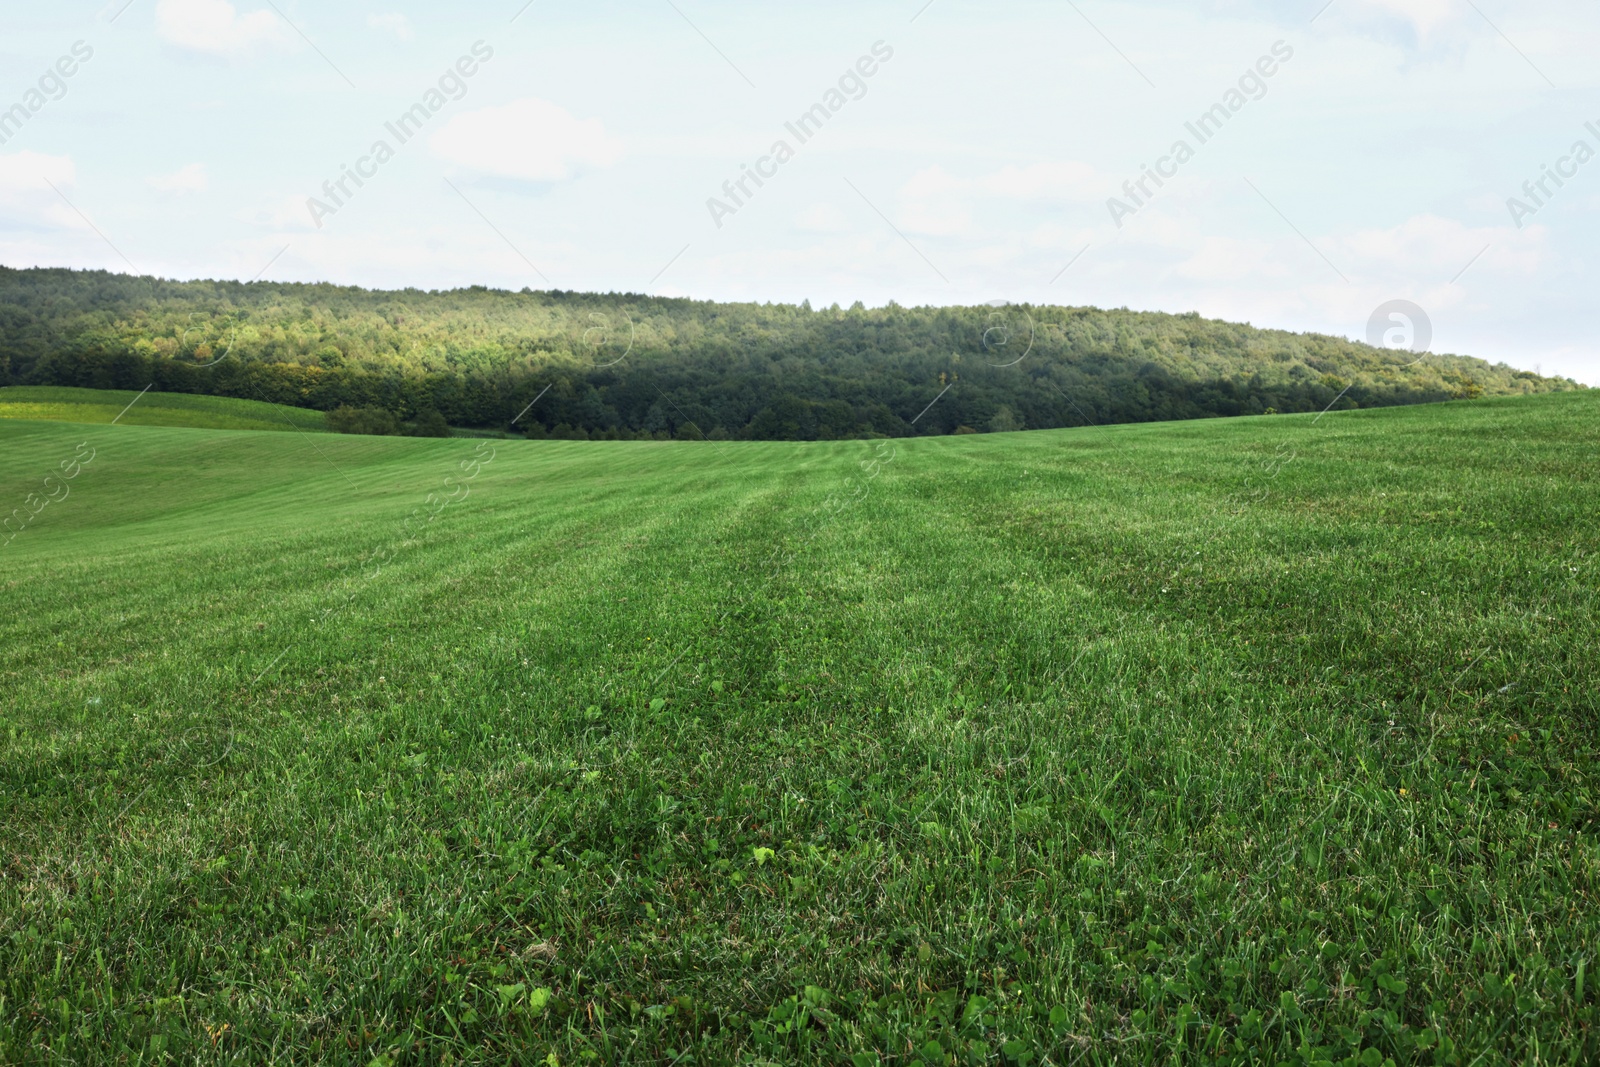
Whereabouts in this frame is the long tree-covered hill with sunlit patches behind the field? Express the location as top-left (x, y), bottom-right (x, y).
top-left (0, 267), bottom-right (1579, 438)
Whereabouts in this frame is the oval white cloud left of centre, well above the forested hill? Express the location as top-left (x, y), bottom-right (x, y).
top-left (429, 99), bottom-right (622, 181)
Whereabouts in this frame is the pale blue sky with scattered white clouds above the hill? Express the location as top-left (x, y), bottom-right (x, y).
top-left (0, 0), bottom-right (1600, 384)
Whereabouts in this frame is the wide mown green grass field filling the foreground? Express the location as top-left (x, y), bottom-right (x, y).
top-left (0, 394), bottom-right (1600, 1067)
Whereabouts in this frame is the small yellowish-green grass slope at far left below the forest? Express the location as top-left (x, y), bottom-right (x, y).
top-left (0, 386), bottom-right (328, 435)
